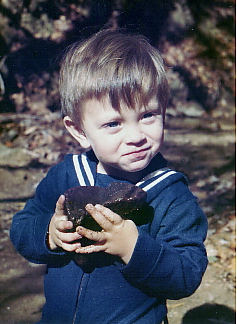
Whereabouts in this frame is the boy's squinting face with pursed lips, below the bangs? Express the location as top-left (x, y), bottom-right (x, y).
top-left (65, 99), bottom-right (163, 180)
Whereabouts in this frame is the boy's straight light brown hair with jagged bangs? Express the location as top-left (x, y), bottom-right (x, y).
top-left (59, 30), bottom-right (169, 123)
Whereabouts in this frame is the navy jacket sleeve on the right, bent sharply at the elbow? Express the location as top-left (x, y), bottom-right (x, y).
top-left (121, 183), bottom-right (207, 299)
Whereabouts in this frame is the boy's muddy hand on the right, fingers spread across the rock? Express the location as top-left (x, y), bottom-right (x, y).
top-left (75, 204), bottom-right (138, 264)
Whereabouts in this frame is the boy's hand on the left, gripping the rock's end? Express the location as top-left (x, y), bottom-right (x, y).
top-left (48, 195), bottom-right (82, 252)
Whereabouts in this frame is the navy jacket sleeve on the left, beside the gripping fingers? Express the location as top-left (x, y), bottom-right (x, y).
top-left (10, 158), bottom-right (73, 263)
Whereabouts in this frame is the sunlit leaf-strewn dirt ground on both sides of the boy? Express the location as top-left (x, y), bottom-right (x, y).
top-left (0, 113), bottom-right (235, 324)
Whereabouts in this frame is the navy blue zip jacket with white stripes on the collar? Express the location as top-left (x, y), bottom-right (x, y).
top-left (10, 152), bottom-right (207, 324)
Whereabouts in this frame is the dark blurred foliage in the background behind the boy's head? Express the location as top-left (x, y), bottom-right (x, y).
top-left (0, 0), bottom-right (235, 112)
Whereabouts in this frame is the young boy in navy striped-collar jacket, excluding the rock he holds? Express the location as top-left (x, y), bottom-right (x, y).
top-left (11, 31), bottom-right (207, 324)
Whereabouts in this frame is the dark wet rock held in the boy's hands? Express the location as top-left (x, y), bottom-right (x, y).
top-left (65, 182), bottom-right (154, 231)
